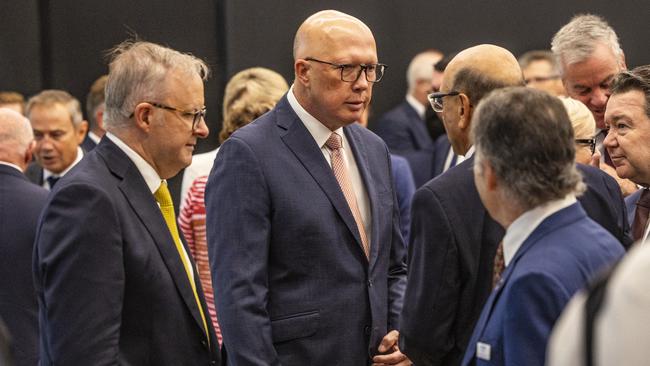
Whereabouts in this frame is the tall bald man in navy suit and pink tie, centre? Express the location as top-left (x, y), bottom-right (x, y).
top-left (206, 10), bottom-right (410, 366)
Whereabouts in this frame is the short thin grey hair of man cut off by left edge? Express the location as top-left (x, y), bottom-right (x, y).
top-left (0, 108), bottom-right (34, 155)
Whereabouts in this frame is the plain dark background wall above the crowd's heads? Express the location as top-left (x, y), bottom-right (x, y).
top-left (0, 0), bottom-right (650, 151)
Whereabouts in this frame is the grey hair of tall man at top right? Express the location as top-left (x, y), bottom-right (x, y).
top-left (551, 14), bottom-right (623, 73)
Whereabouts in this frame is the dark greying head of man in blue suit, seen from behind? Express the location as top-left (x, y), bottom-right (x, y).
top-left (471, 87), bottom-right (585, 210)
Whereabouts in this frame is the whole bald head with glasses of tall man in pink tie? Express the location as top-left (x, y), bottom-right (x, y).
top-left (293, 10), bottom-right (383, 131)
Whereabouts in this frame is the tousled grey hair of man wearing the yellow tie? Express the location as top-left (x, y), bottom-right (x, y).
top-left (104, 40), bottom-right (209, 128)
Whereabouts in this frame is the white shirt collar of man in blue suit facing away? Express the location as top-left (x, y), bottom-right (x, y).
top-left (503, 193), bottom-right (577, 266)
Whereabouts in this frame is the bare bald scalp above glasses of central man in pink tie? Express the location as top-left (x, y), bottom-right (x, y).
top-left (293, 10), bottom-right (374, 61)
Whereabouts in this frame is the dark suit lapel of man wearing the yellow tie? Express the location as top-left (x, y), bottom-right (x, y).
top-left (96, 139), bottom-right (208, 334)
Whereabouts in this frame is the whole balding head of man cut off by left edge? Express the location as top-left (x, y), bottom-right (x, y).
top-left (0, 108), bottom-right (34, 171)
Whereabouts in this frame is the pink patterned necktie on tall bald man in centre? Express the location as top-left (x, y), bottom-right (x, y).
top-left (325, 132), bottom-right (370, 258)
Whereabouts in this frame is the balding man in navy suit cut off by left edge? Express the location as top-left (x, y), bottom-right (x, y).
top-left (0, 108), bottom-right (48, 365)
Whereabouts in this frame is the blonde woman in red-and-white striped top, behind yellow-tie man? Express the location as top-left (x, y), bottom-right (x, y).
top-left (178, 67), bottom-right (289, 344)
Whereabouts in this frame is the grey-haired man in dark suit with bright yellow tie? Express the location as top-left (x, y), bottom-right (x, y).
top-left (33, 41), bottom-right (220, 365)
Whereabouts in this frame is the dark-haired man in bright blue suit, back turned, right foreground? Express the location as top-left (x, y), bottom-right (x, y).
top-left (462, 87), bottom-right (624, 366)
